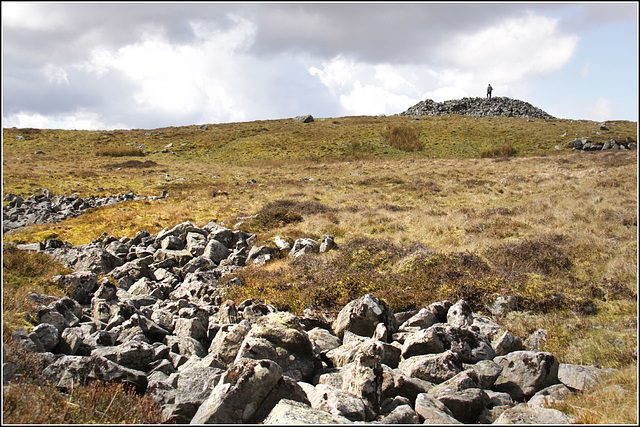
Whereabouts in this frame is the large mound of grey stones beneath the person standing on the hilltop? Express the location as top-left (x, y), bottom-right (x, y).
top-left (400, 96), bottom-right (554, 119)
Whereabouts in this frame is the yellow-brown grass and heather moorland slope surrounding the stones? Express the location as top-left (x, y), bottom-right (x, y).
top-left (3, 116), bottom-right (637, 423)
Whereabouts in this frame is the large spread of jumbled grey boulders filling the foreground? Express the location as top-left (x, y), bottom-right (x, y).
top-left (3, 221), bottom-right (606, 424)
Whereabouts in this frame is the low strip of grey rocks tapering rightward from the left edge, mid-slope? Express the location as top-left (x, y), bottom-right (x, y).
top-left (2, 188), bottom-right (167, 233)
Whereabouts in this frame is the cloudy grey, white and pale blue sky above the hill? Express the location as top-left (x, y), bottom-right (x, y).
top-left (2, 1), bottom-right (638, 130)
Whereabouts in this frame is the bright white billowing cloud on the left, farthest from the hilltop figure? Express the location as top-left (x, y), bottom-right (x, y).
top-left (78, 16), bottom-right (259, 121)
